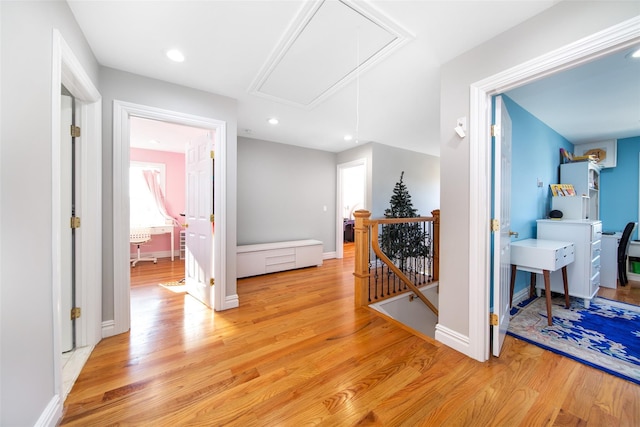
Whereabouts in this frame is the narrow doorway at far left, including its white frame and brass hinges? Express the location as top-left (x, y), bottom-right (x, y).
top-left (51, 30), bottom-right (102, 401)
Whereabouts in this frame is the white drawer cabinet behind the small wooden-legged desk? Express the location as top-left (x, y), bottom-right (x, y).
top-left (536, 221), bottom-right (602, 307)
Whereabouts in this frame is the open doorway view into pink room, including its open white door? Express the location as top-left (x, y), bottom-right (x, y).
top-left (129, 117), bottom-right (214, 307)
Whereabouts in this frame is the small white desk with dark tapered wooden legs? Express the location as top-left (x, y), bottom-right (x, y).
top-left (511, 239), bottom-right (574, 326)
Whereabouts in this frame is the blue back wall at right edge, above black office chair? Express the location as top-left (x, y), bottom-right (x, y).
top-left (600, 136), bottom-right (640, 239)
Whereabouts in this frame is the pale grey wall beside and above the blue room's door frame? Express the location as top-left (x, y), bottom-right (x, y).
top-left (439, 1), bottom-right (640, 358)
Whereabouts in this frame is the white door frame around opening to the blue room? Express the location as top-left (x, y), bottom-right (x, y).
top-left (467, 17), bottom-right (640, 361)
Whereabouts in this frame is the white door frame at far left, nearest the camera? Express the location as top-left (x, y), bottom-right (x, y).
top-left (51, 29), bottom-right (102, 404)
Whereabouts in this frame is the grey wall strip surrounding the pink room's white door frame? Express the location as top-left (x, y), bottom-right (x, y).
top-left (100, 67), bottom-right (238, 321)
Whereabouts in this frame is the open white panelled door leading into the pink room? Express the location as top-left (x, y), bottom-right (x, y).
top-left (185, 132), bottom-right (215, 307)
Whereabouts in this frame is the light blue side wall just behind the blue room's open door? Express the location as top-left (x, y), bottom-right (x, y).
top-left (503, 95), bottom-right (576, 293)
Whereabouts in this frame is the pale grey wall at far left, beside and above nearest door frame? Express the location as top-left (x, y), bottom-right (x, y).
top-left (0, 1), bottom-right (98, 426)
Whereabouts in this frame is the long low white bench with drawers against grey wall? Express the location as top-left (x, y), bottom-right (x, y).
top-left (237, 240), bottom-right (322, 278)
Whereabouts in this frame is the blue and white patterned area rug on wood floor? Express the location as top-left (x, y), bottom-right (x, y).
top-left (507, 296), bottom-right (640, 384)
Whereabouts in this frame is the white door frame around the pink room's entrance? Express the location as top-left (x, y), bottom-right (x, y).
top-left (111, 100), bottom-right (232, 336)
